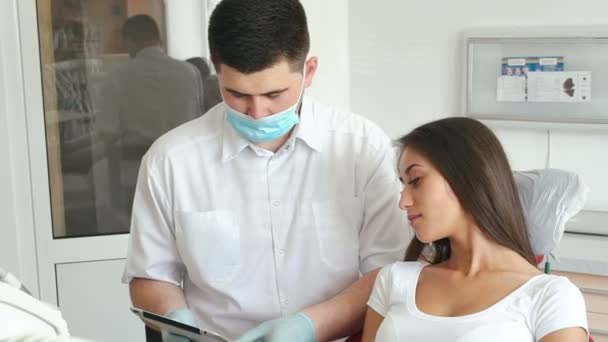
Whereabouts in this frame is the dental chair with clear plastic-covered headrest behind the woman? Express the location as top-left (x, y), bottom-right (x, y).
top-left (346, 169), bottom-right (593, 342)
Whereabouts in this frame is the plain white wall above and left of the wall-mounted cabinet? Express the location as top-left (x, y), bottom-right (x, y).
top-left (349, 0), bottom-right (608, 137)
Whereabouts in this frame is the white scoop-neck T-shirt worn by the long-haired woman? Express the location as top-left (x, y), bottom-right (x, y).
top-left (368, 262), bottom-right (587, 342)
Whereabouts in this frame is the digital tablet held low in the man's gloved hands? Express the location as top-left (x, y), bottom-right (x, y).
top-left (131, 307), bottom-right (230, 342)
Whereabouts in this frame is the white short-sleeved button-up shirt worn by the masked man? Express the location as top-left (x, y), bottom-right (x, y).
top-left (123, 97), bottom-right (410, 338)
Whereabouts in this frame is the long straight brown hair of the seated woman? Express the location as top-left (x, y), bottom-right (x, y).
top-left (398, 117), bottom-right (535, 265)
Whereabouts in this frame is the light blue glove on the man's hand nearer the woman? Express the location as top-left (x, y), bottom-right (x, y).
top-left (234, 312), bottom-right (315, 342)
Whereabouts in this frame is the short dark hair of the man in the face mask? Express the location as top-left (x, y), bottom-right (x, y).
top-left (208, 0), bottom-right (310, 74)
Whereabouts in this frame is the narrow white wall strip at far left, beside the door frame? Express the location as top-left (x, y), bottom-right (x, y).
top-left (0, 0), bottom-right (38, 294)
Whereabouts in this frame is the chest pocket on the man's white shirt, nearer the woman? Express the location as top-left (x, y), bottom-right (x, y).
top-left (312, 198), bottom-right (362, 270)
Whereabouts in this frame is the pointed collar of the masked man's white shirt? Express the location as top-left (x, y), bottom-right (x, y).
top-left (222, 96), bottom-right (322, 163)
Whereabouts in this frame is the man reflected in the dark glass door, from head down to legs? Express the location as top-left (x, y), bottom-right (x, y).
top-left (94, 15), bottom-right (204, 227)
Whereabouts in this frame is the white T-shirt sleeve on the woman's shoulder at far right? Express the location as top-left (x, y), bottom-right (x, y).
top-left (535, 277), bottom-right (589, 340)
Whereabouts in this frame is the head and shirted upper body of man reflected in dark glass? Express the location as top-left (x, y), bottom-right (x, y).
top-left (97, 14), bottom-right (204, 152)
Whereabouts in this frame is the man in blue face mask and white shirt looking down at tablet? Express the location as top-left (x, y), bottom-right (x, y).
top-left (123, 0), bottom-right (409, 342)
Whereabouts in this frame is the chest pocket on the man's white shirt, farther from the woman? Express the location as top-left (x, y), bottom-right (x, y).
top-left (175, 210), bottom-right (241, 285)
